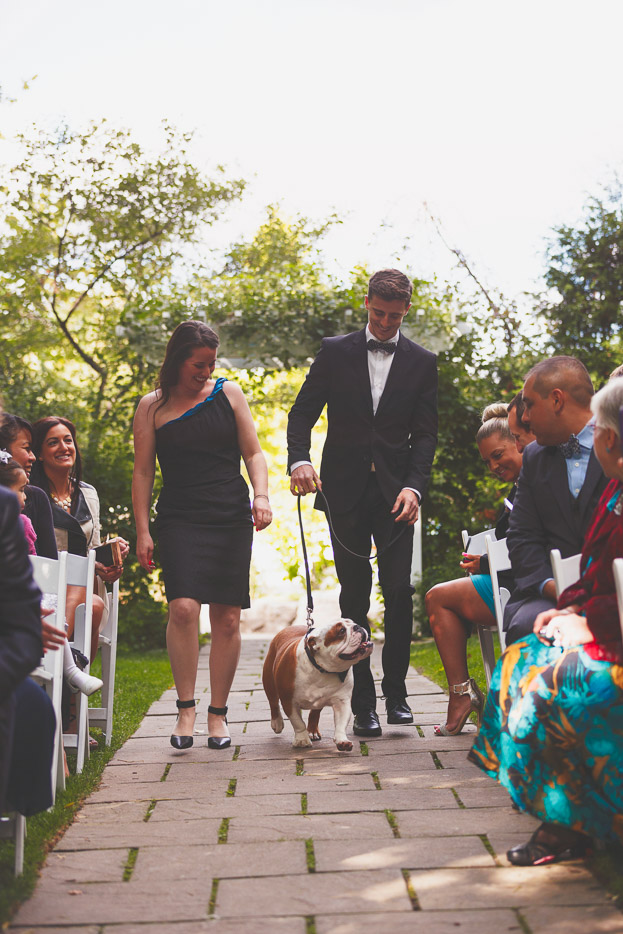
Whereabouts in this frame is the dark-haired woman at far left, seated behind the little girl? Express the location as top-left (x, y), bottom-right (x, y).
top-left (0, 412), bottom-right (58, 558)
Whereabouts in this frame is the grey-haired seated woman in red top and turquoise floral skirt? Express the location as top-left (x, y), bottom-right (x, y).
top-left (469, 380), bottom-right (623, 866)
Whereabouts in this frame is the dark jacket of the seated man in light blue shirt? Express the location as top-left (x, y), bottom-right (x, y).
top-left (504, 441), bottom-right (608, 622)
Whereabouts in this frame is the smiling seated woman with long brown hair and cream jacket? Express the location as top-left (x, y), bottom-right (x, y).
top-left (31, 416), bottom-right (129, 661)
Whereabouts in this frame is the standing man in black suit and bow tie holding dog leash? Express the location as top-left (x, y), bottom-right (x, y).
top-left (288, 269), bottom-right (437, 736)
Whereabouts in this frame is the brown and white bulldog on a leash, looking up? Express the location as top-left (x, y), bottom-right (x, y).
top-left (262, 619), bottom-right (373, 752)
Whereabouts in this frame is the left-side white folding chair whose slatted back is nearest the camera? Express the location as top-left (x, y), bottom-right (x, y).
top-left (30, 551), bottom-right (67, 800)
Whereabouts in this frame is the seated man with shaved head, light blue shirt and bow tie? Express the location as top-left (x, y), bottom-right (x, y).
top-left (504, 356), bottom-right (607, 645)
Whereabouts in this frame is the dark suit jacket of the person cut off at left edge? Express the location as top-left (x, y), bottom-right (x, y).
top-left (0, 487), bottom-right (43, 811)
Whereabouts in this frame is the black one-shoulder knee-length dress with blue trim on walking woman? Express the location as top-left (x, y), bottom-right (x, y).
top-left (155, 378), bottom-right (253, 608)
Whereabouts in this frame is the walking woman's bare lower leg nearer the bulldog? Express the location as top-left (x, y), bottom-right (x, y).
top-left (208, 603), bottom-right (240, 737)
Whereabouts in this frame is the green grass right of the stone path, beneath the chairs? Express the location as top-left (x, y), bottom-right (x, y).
top-left (411, 635), bottom-right (623, 909)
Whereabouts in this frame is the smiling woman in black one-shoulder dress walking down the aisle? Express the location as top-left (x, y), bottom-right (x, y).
top-left (132, 321), bottom-right (272, 749)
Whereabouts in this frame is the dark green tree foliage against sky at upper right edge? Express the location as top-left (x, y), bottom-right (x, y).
top-left (541, 181), bottom-right (623, 385)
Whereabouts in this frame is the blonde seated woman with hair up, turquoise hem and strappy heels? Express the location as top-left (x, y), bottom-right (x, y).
top-left (426, 402), bottom-right (521, 736)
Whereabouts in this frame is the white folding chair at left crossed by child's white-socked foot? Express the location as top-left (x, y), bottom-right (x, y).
top-left (63, 551), bottom-right (95, 774)
